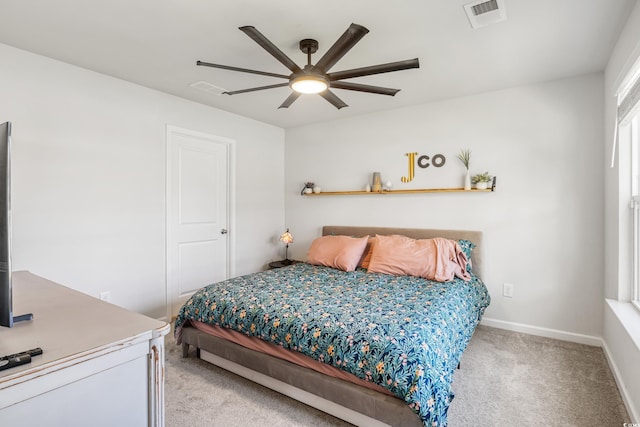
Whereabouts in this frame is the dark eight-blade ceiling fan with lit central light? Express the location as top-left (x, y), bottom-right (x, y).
top-left (196, 24), bottom-right (420, 109)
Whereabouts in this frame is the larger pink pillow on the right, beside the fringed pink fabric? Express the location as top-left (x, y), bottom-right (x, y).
top-left (368, 235), bottom-right (435, 277)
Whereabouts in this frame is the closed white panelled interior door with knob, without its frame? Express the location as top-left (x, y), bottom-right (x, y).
top-left (167, 127), bottom-right (232, 317)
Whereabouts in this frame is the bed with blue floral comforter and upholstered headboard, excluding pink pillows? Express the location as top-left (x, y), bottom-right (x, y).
top-left (175, 226), bottom-right (490, 427)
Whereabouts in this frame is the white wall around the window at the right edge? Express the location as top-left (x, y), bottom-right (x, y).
top-left (603, 3), bottom-right (640, 422)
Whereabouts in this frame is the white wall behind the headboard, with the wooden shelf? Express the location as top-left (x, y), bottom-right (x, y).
top-left (285, 73), bottom-right (604, 337)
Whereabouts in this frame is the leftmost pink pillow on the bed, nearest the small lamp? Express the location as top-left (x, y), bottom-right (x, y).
top-left (307, 236), bottom-right (369, 271)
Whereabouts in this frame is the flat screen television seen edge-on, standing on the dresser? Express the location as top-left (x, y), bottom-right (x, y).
top-left (0, 122), bottom-right (33, 328)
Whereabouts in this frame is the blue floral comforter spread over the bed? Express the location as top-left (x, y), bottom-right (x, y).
top-left (175, 263), bottom-right (490, 426)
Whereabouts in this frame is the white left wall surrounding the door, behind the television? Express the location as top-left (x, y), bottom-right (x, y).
top-left (0, 45), bottom-right (284, 317)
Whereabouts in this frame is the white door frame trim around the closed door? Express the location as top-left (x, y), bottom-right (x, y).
top-left (162, 125), bottom-right (236, 322)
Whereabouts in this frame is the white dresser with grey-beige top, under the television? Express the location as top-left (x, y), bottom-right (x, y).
top-left (0, 271), bottom-right (169, 427)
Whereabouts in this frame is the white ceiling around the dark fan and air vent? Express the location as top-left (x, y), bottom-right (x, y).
top-left (0, 0), bottom-right (635, 128)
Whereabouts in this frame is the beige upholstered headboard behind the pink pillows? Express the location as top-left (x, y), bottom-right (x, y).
top-left (322, 225), bottom-right (482, 278)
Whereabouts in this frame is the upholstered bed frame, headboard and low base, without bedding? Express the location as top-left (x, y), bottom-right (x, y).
top-left (182, 226), bottom-right (482, 427)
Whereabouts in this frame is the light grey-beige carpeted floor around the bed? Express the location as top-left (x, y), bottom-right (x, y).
top-left (165, 326), bottom-right (630, 427)
